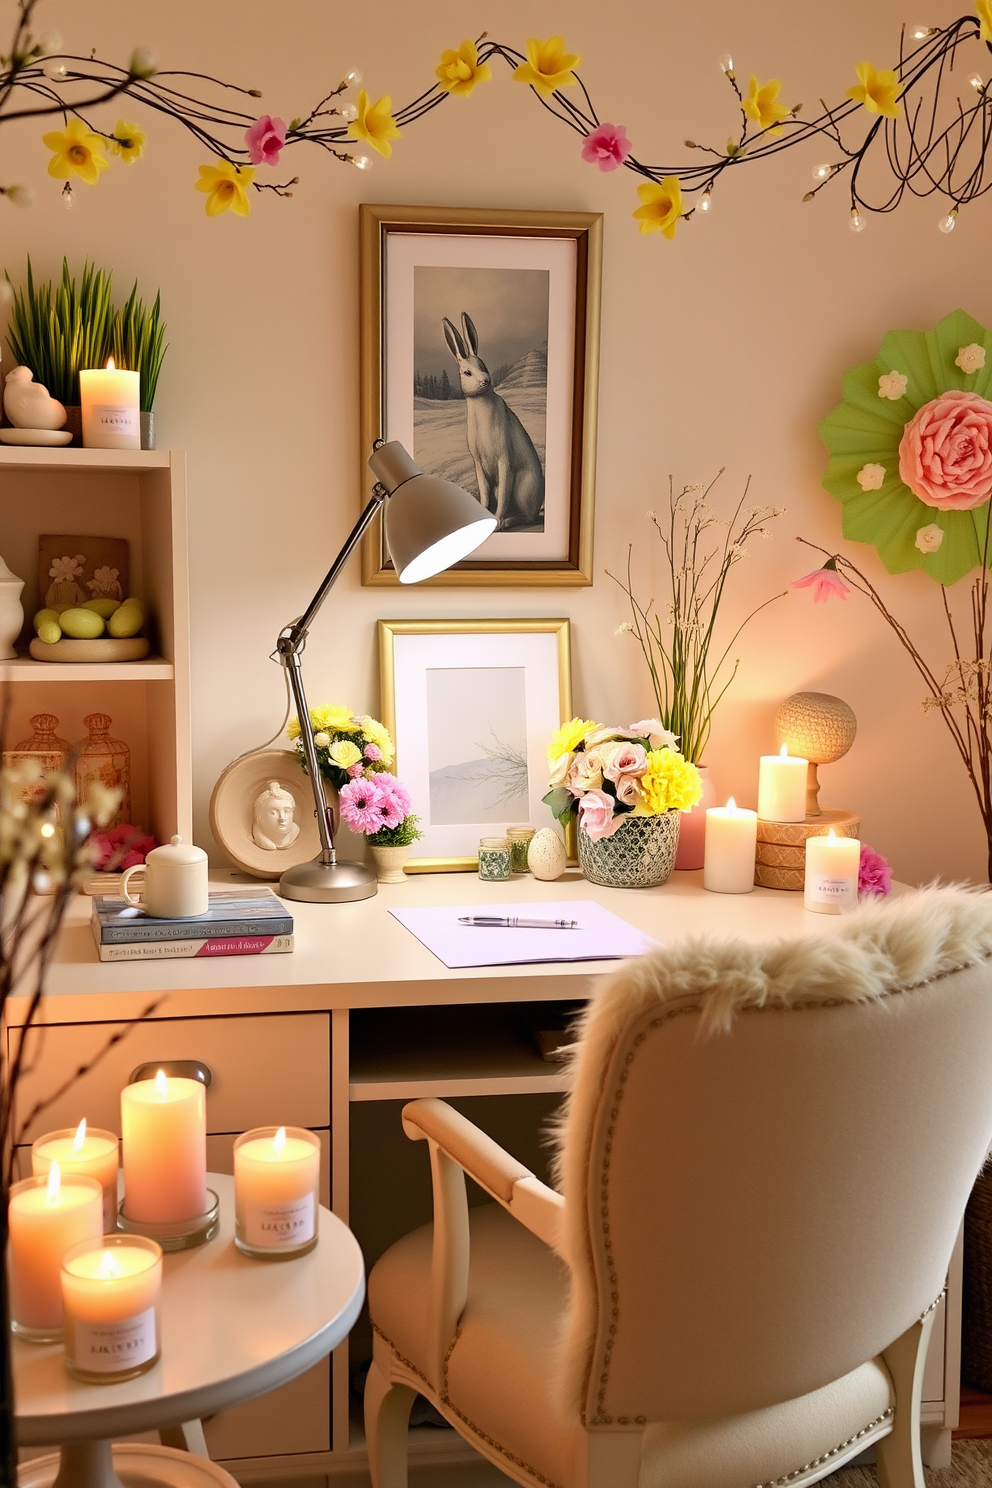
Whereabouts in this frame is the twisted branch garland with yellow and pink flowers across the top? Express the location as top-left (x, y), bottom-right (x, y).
top-left (0, 0), bottom-right (992, 227)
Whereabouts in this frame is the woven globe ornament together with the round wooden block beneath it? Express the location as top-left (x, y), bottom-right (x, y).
top-left (754, 692), bottom-right (861, 891)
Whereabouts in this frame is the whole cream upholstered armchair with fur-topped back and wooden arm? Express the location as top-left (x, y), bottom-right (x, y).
top-left (366, 890), bottom-right (992, 1488)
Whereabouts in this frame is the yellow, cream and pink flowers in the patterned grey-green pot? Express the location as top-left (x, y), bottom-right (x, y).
top-left (544, 719), bottom-right (702, 842)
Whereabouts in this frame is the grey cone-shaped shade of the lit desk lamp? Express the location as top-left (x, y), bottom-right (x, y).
top-left (369, 440), bottom-right (495, 583)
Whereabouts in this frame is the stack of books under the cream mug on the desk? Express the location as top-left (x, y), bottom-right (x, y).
top-left (91, 888), bottom-right (293, 961)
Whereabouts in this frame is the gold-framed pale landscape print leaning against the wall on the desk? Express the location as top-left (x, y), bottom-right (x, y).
top-left (379, 619), bottom-right (571, 873)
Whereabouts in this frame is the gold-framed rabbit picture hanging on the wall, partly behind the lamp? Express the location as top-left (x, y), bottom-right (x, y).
top-left (360, 205), bottom-right (602, 588)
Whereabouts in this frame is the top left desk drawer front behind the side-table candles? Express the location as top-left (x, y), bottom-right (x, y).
top-left (7, 1013), bottom-right (330, 1141)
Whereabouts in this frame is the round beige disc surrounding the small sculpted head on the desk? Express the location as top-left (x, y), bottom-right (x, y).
top-left (210, 748), bottom-right (338, 878)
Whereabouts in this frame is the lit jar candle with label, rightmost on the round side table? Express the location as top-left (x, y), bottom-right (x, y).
top-left (233, 1126), bottom-right (320, 1260)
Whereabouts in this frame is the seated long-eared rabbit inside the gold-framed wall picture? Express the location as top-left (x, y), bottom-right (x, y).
top-left (442, 311), bottom-right (544, 533)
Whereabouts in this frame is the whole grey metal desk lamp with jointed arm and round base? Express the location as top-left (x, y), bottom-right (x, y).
top-left (275, 440), bottom-right (495, 905)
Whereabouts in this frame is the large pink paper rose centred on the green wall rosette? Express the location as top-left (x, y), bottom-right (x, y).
top-left (898, 391), bottom-right (992, 512)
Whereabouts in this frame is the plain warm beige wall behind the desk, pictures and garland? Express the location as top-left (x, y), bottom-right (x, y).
top-left (0, 0), bottom-right (992, 879)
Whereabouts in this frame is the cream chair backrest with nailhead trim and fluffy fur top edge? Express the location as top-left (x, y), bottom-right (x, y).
top-left (561, 890), bottom-right (992, 1426)
